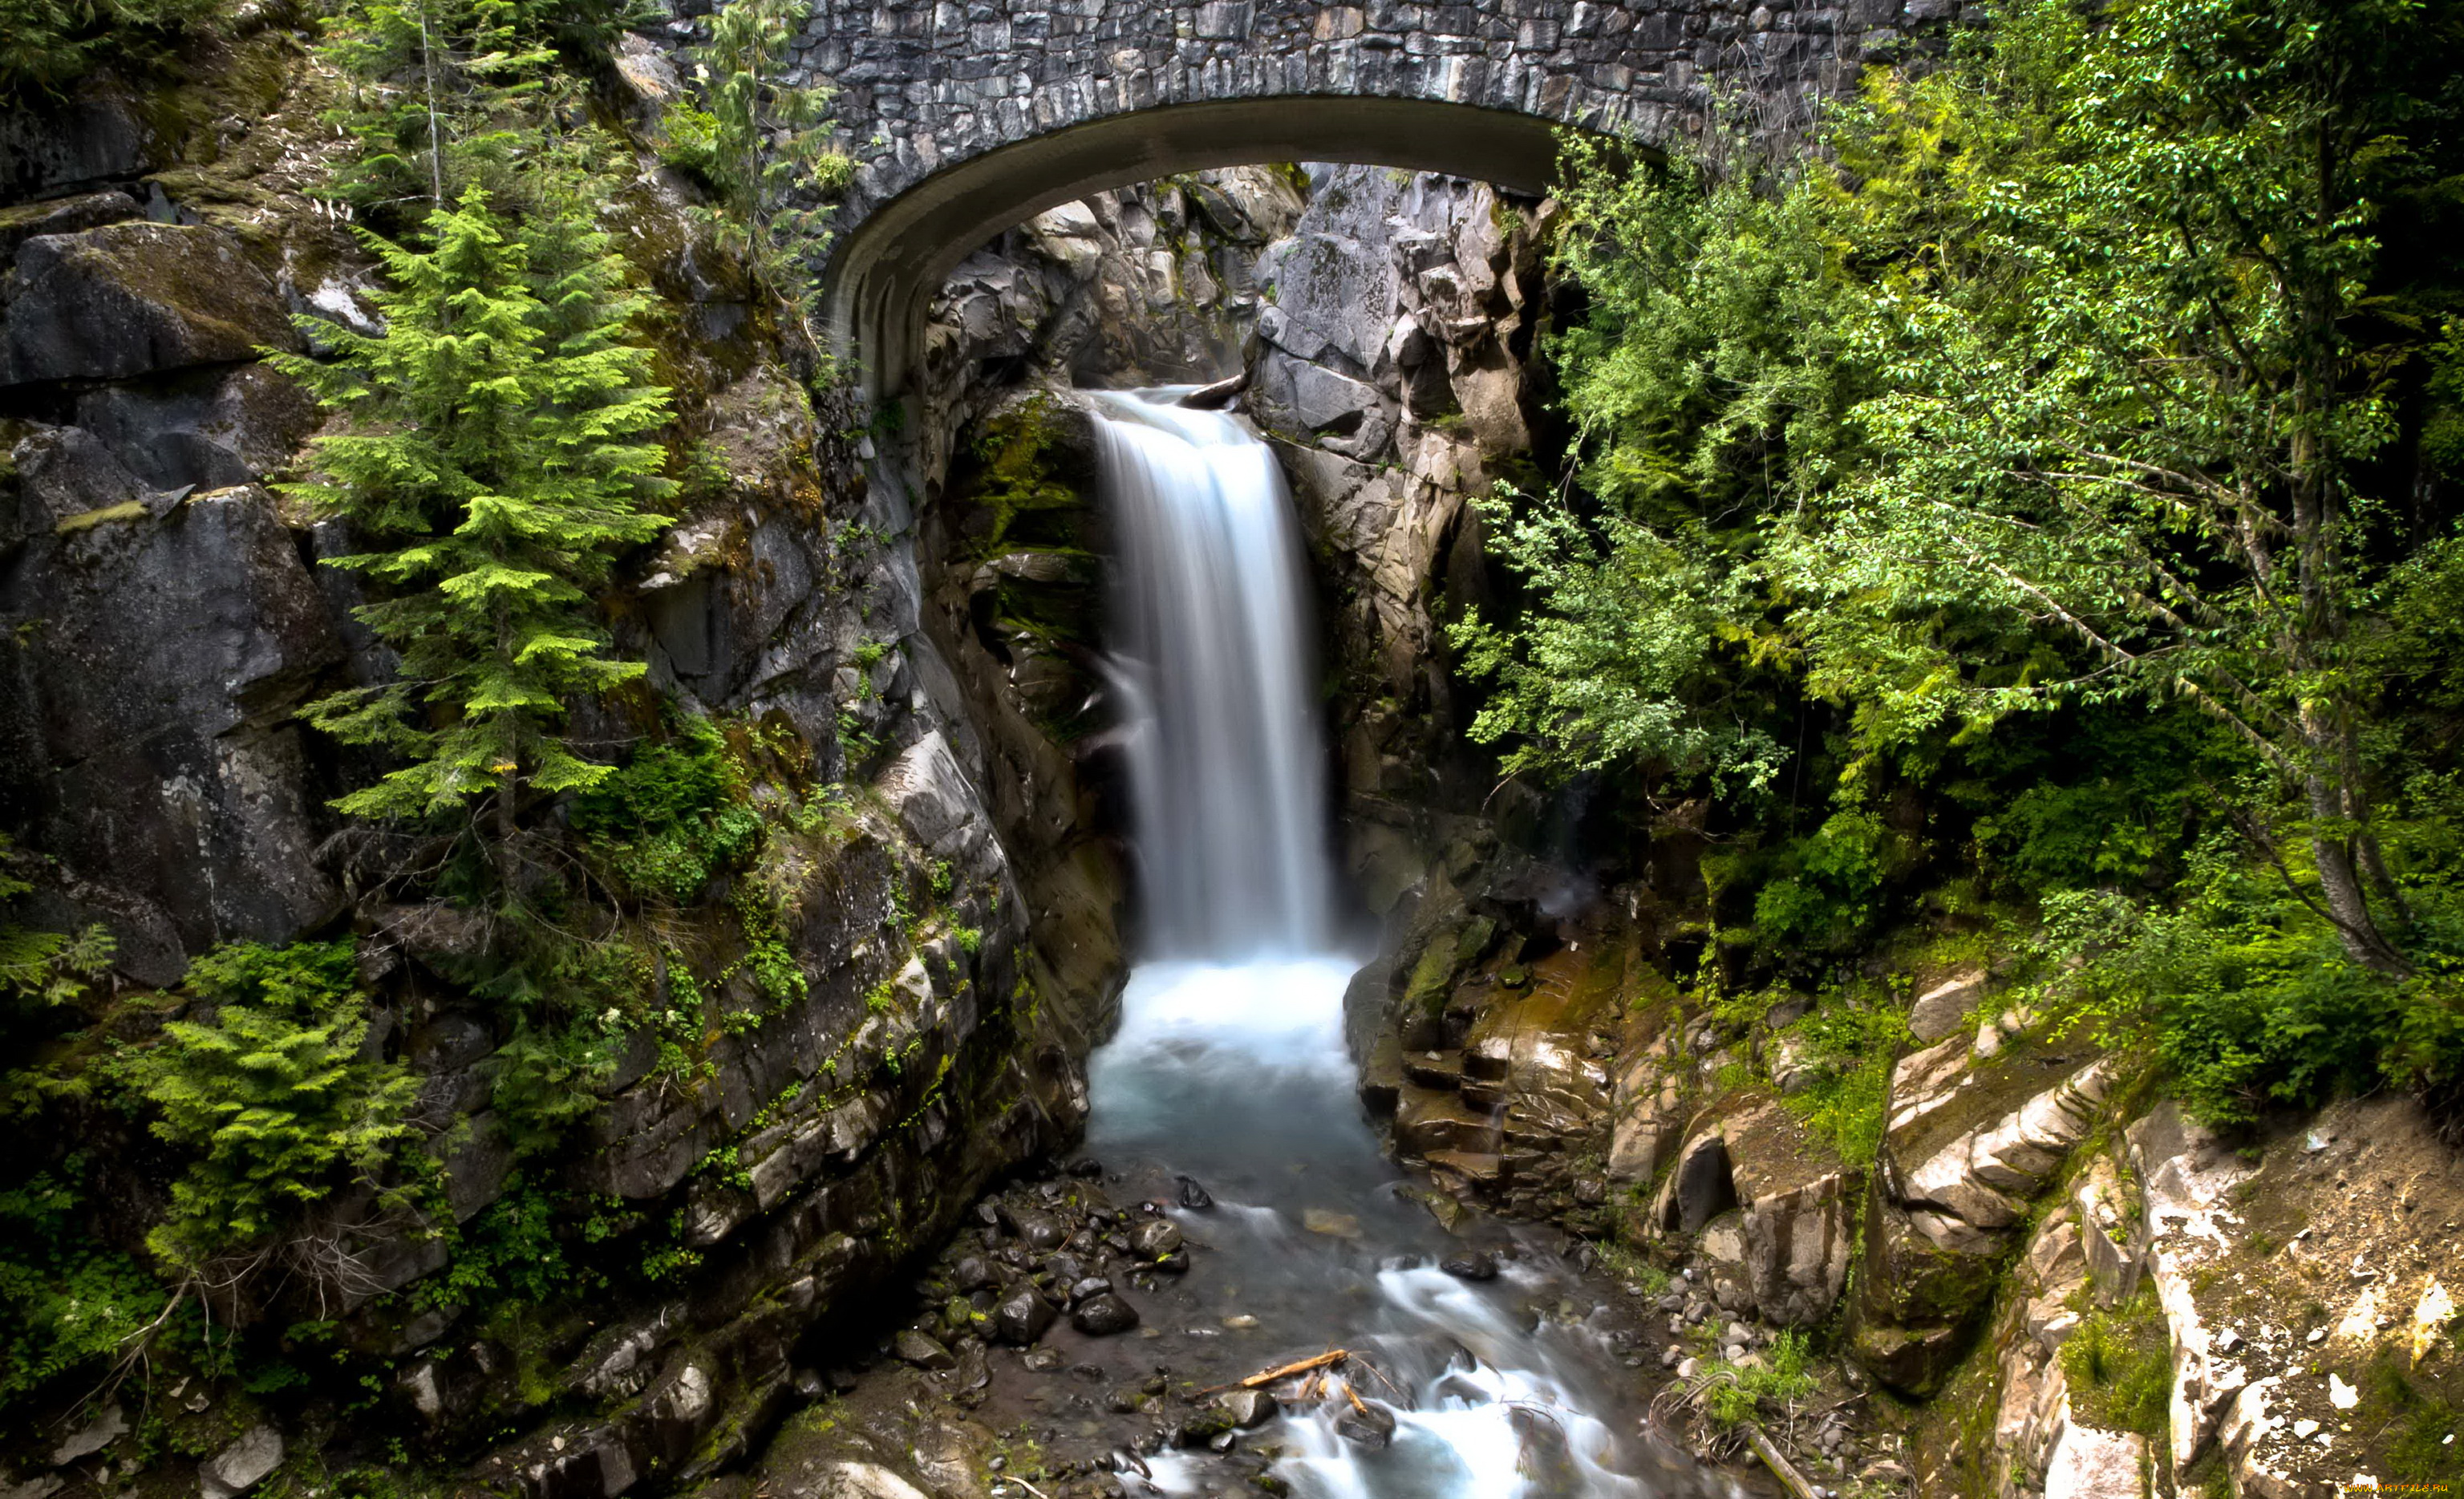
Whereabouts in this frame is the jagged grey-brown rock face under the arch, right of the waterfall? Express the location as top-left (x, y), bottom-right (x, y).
top-left (1246, 168), bottom-right (1545, 853)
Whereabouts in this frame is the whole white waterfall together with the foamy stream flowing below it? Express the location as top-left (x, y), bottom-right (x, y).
top-left (1089, 392), bottom-right (1732, 1499)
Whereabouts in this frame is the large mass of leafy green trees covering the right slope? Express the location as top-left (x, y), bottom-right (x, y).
top-left (1488, 0), bottom-right (2464, 1089)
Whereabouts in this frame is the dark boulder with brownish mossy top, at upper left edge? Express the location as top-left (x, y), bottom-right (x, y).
top-left (0, 222), bottom-right (303, 387)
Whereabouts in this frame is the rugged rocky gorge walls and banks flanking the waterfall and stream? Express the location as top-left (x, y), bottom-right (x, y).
top-left (0, 10), bottom-right (2464, 1499)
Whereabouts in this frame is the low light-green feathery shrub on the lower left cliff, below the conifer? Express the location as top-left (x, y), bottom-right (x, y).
top-left (133, 942), bottom-right (419, 1272)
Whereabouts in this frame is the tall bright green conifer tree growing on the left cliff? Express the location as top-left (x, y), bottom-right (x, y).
top-left (281, 188), bottom-right (671, 895)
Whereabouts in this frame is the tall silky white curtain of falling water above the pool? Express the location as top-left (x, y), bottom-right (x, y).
top-left (1096, 395), bottom-right (1331, 957)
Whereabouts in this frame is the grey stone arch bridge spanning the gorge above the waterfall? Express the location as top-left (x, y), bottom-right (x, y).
top-left (798, 0), bottom-right (1961, 395)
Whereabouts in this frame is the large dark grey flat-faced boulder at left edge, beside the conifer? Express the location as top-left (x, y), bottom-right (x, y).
top-left (0, 488), bottom-right (342, 984)
